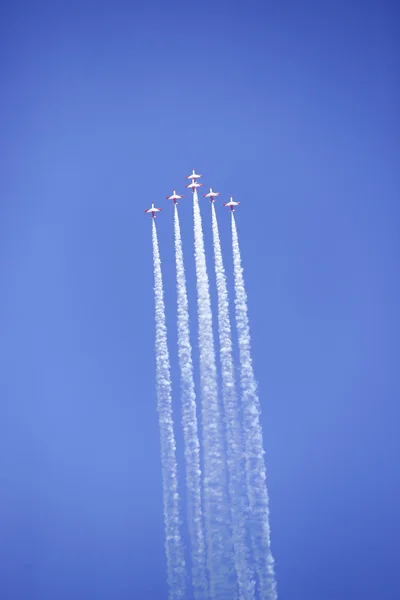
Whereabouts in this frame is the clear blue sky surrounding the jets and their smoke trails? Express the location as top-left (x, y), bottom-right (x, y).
top-left (0, 0), bottom-right (400, 600)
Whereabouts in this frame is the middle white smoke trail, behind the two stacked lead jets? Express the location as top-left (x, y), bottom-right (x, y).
top-left (193, 190), bottom-right (237, 600)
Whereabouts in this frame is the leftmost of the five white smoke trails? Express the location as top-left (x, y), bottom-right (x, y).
top-left (152, 219), bottom-right (186, 600)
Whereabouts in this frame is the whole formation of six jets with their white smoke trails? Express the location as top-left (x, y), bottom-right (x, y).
top-left (150, 169), bottom-right (277, 600)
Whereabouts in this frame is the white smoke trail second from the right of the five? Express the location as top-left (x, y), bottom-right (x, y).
top-left (211, 204), bottom-right (255, 600)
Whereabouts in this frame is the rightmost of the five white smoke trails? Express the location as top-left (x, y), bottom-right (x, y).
top-left (232, 213), bottom-right (278, 600)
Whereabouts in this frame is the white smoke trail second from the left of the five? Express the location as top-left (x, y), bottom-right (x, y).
top-left (174, 204), bottom-right (208, 600)
